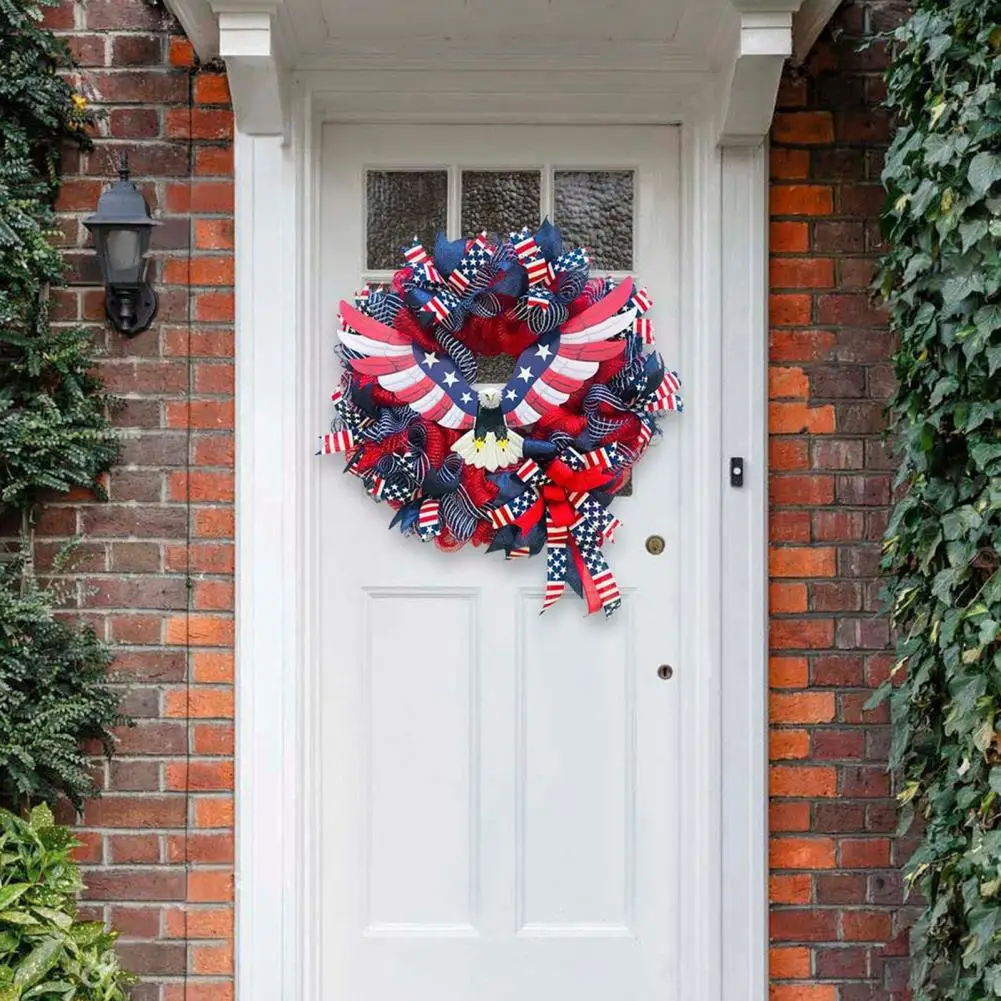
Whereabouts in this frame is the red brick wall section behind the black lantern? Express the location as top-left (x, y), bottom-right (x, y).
top-left (45, 0), bottom-right (233, 1001)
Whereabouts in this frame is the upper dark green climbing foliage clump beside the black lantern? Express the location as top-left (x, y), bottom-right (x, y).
top-left (0, 0), bottom-right (117, 512)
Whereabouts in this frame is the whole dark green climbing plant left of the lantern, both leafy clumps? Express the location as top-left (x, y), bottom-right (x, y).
top-left (0, 0), bottom-right (122, 812)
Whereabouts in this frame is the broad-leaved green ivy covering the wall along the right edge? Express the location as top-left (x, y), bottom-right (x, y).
top-left (877, 0), bottom-right (1001, 1001)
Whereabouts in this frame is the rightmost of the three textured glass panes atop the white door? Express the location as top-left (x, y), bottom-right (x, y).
top-left (553, 170), bottom-right (633, 271)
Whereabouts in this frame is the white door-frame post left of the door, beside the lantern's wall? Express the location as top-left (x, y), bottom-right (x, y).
top-left (235, 113), bottom-right (312, 999)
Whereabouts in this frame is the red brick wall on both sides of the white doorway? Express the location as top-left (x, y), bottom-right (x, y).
top-left (39, 0), bottom-right (906, 1001)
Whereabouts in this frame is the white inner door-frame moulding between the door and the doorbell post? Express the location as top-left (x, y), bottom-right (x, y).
top-left (677, 122), bottom-right (730, 999)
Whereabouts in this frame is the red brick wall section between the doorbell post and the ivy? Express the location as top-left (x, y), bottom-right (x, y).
top-left (770, 0), bottom-right (907, 1001)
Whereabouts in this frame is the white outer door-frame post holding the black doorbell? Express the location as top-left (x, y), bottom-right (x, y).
top-left (721, 145), bottom-right (768, 998)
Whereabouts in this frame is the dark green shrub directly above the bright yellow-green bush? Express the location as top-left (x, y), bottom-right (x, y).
top-left (0, 562), bottom-right (128, 816)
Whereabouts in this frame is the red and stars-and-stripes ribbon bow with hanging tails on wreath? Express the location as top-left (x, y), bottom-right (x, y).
top-left (487, 444), bottom-right (622, 617)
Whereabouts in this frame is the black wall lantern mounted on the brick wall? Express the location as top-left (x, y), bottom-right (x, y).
top-left (83, 156), bottom-right (159, 337)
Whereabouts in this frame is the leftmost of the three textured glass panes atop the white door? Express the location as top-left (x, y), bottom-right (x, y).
top-left (365, 170), bottom-right (448, 270)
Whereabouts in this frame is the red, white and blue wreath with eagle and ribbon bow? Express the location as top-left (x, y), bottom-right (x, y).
top-left (320, 221), bottom-right (682, 616)
